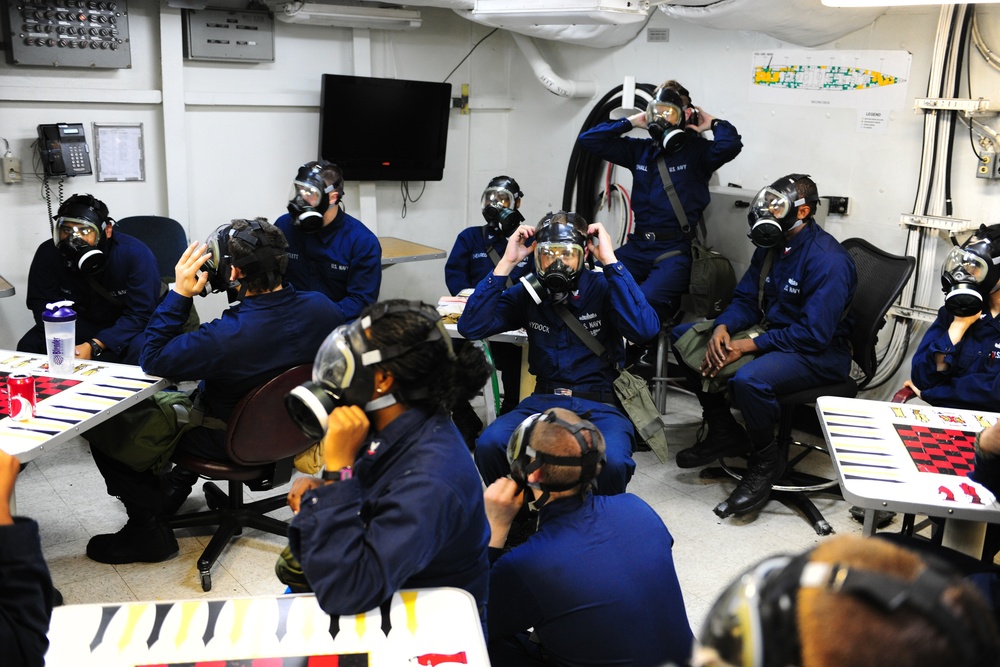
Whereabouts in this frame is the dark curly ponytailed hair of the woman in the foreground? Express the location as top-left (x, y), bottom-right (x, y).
top-left (361, 299), bottom-right (493, 411)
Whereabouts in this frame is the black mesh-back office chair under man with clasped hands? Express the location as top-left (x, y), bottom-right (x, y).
top-left (722, 238), bottom-right (916, 535)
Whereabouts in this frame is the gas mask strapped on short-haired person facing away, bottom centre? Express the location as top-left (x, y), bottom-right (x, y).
top-left (507, 410), bottom-right (605, 510)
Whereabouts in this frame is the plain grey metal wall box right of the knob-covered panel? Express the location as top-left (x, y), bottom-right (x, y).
top-left (184, 9), bottom-right (274, 63)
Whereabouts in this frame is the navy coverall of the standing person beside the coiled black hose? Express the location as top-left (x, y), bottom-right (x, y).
top-left (577, 118), bottom-right (743, 319)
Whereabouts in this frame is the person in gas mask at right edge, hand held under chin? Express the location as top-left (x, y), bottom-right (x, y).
top-left (905, 225), bottom-right (1000, 410)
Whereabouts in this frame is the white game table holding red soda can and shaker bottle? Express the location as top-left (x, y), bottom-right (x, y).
top-left (0, 349), bottom-right (168, 463)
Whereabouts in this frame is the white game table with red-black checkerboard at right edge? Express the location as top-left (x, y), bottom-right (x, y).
top-left (816, 396), bottom-right (1000, 557)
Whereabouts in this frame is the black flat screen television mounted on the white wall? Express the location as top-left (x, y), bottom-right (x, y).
top-left (319, 74), bottom-right (451, 181)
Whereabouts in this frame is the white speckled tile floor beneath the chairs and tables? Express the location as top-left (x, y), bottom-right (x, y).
top-left (17, 392), bottom-right (861, 631)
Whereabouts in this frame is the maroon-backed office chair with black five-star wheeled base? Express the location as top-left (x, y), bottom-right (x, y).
top-left (169, 364), bottom-right (313, 591)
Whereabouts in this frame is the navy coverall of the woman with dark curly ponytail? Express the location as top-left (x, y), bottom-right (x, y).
top-left (288, 408), bottom-right (490, 616)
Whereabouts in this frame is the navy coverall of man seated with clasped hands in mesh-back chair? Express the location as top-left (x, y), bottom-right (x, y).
top-left (671, 218), bottom-right (858, 447)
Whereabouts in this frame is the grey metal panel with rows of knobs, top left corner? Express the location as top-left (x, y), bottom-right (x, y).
top-left (2, 0), bottom-right (132, 69)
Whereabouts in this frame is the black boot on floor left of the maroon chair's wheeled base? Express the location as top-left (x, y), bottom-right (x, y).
top-left (87, 506), bottom-right (179, 565)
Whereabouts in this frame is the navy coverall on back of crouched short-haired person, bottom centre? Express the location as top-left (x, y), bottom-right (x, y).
top-left (487, 493), bottom-right (693, 667)
